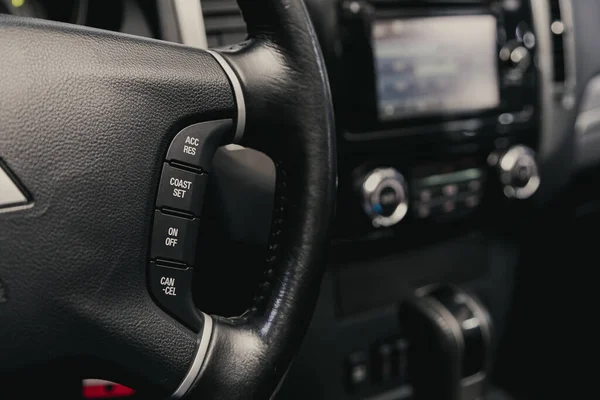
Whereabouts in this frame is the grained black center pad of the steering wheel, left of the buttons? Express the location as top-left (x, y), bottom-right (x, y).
top-left (0, 16), bottom-right (236, 393)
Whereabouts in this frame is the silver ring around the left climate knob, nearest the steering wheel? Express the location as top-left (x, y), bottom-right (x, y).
top-left (360, 168), bottom-right (408, 228)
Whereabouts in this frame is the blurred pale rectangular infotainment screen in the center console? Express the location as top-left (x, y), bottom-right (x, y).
top-left (373, 15), bottom-right (500, 121)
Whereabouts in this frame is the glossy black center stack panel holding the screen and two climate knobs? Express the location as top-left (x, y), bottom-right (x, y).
top-left (335, 0), bottom-right (540, 242)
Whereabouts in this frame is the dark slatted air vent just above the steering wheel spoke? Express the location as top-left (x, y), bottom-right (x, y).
top-left (201, 0), bottom-right (246, 47)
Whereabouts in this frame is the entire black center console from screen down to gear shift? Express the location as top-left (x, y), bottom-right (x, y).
top-left (279, 0), bottom-right (542, 400)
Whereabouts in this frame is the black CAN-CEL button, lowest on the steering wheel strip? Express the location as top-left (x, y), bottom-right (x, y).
top-left (148, 262), bottom-right (202, 331)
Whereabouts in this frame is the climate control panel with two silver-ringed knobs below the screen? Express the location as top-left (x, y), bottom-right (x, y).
top-left (353, 144), bottom-right (541, 229)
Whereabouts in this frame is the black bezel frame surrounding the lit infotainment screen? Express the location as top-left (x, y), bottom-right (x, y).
top-left (332, 6), bottom-right (506, 136)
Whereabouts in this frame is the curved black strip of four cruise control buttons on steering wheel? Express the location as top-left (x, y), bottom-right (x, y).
top-left (148, 119), bottom-right (234, 332)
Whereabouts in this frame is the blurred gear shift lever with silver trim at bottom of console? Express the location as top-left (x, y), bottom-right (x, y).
top-left (400, 285), bottom-right (492, 400)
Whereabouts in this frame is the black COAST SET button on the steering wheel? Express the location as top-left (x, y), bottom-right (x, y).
top-left (156, 164), bottom-right (208, 216)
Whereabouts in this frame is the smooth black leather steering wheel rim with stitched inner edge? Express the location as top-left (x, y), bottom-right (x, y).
top-left (192, 0), bottom-right (336, 399)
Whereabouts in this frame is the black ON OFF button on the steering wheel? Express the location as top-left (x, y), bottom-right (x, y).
top-left (150, 211), bottom-right (200, 266)
